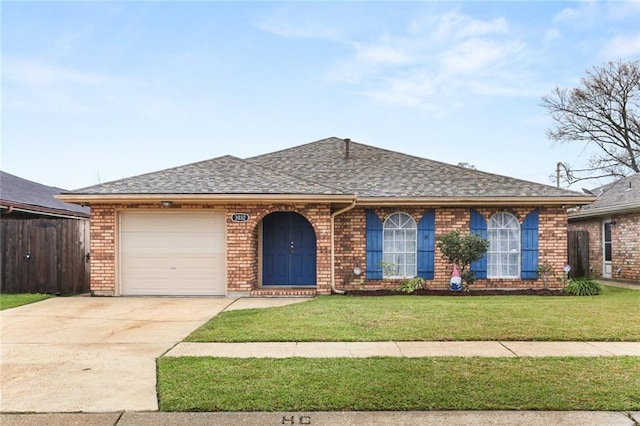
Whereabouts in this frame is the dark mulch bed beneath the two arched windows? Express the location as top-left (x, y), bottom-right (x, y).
top-left (345, 288), bottom-right (571, 297)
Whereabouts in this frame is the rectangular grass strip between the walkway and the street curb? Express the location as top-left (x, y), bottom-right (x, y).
top-left (158, 357), bottom-right (640, 411)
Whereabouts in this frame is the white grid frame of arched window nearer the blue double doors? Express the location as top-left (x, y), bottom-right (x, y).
top-left (382, 211), bottom-right (418, 279)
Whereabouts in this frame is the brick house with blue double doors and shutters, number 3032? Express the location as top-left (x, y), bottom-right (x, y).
top-left (58, 138), bottom-right (593, 295)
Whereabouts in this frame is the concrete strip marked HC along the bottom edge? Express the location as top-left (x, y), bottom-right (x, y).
top-left (0, 411), bottom-right (640, 426)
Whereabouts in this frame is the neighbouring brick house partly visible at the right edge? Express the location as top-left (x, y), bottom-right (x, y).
top-left (568, 173), bottom-right (640, 282)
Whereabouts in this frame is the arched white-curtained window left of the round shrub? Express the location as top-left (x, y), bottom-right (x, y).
top-left (382, 212), bottom-right (417, 278)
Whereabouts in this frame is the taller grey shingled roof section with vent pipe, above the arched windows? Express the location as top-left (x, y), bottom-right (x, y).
top-left (248, 138), bottom-right (583, 198)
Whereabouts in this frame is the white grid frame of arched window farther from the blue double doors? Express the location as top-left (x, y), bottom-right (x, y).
top-left (487, 211), bottom-right (522, 279)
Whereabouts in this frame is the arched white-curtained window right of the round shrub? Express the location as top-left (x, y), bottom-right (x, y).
top-left (487, 212), bottom-right (520, 278)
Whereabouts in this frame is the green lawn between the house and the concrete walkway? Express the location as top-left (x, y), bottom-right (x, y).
top-left (186, 287), bottom-right (640, 342)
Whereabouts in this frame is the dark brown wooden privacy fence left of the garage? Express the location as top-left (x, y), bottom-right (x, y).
top-left (0, 218), bottom-right (89, 294)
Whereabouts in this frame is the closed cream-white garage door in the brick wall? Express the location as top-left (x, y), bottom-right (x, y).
top-left (120, 212), bottom-right (227, 296)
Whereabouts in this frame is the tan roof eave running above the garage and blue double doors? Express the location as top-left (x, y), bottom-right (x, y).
top-left (55, 193), bottom-right (356, 205)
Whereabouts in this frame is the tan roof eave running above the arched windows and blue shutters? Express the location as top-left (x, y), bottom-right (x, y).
top-left (358, 196), bottom-right (595, 207)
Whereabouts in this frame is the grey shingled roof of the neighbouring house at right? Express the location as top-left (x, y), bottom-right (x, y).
top-left (569, 173), bottom-right (640, 219)
